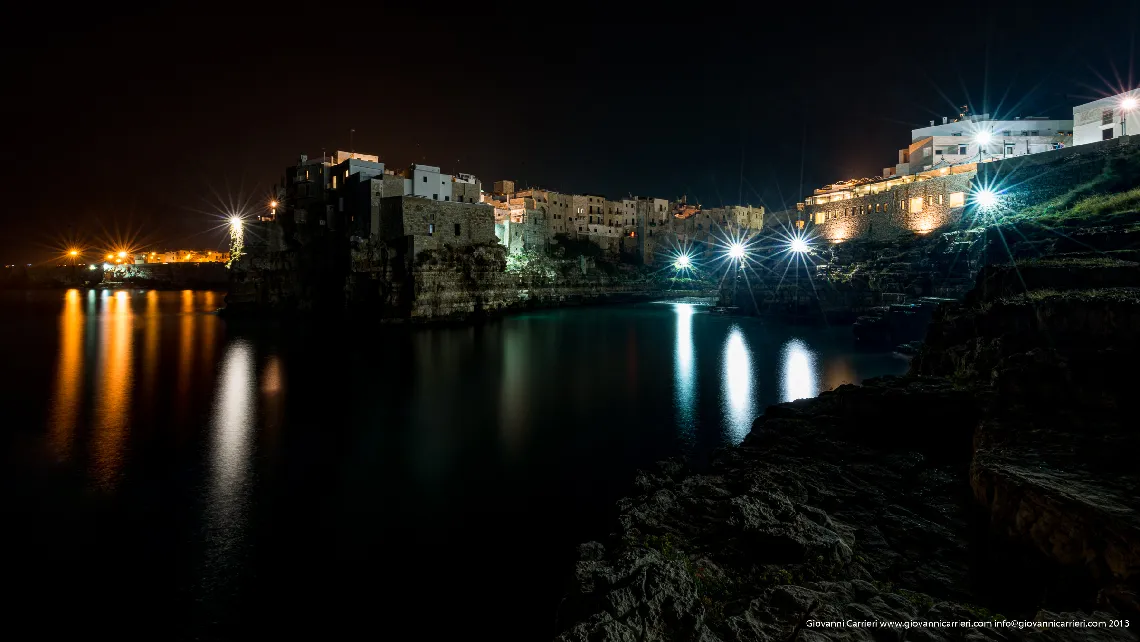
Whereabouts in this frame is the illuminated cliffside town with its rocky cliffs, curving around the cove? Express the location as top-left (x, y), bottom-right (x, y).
top-left (228, 88), bottom-right (1134, 326)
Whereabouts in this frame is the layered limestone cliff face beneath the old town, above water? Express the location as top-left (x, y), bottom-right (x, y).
top-left (227, 233), bottom-right (716, 322)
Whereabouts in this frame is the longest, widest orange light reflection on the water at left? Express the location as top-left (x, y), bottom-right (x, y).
top-left (92, 291), bottom-right (133, 489)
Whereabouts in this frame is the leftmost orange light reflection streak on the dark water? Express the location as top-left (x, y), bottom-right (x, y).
top-left (50, 290), bottom-right (83, 460)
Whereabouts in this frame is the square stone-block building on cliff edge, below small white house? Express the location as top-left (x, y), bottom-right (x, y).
top-left (371, 196), bottom-right (496, 257)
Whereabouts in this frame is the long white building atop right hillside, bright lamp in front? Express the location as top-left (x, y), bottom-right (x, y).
top-left (882, 114), bottom-right (1073, 177)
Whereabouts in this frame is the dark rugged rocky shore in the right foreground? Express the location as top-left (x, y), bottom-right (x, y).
top-left (559, 246), bottom-right (1140, 641)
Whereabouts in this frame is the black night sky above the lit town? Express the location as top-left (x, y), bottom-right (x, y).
top-left (0, 1), bottom-right (1140, 263)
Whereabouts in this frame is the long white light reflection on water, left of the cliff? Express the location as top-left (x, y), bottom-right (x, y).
top-left (206, 340), bottom-right (257, 572)
